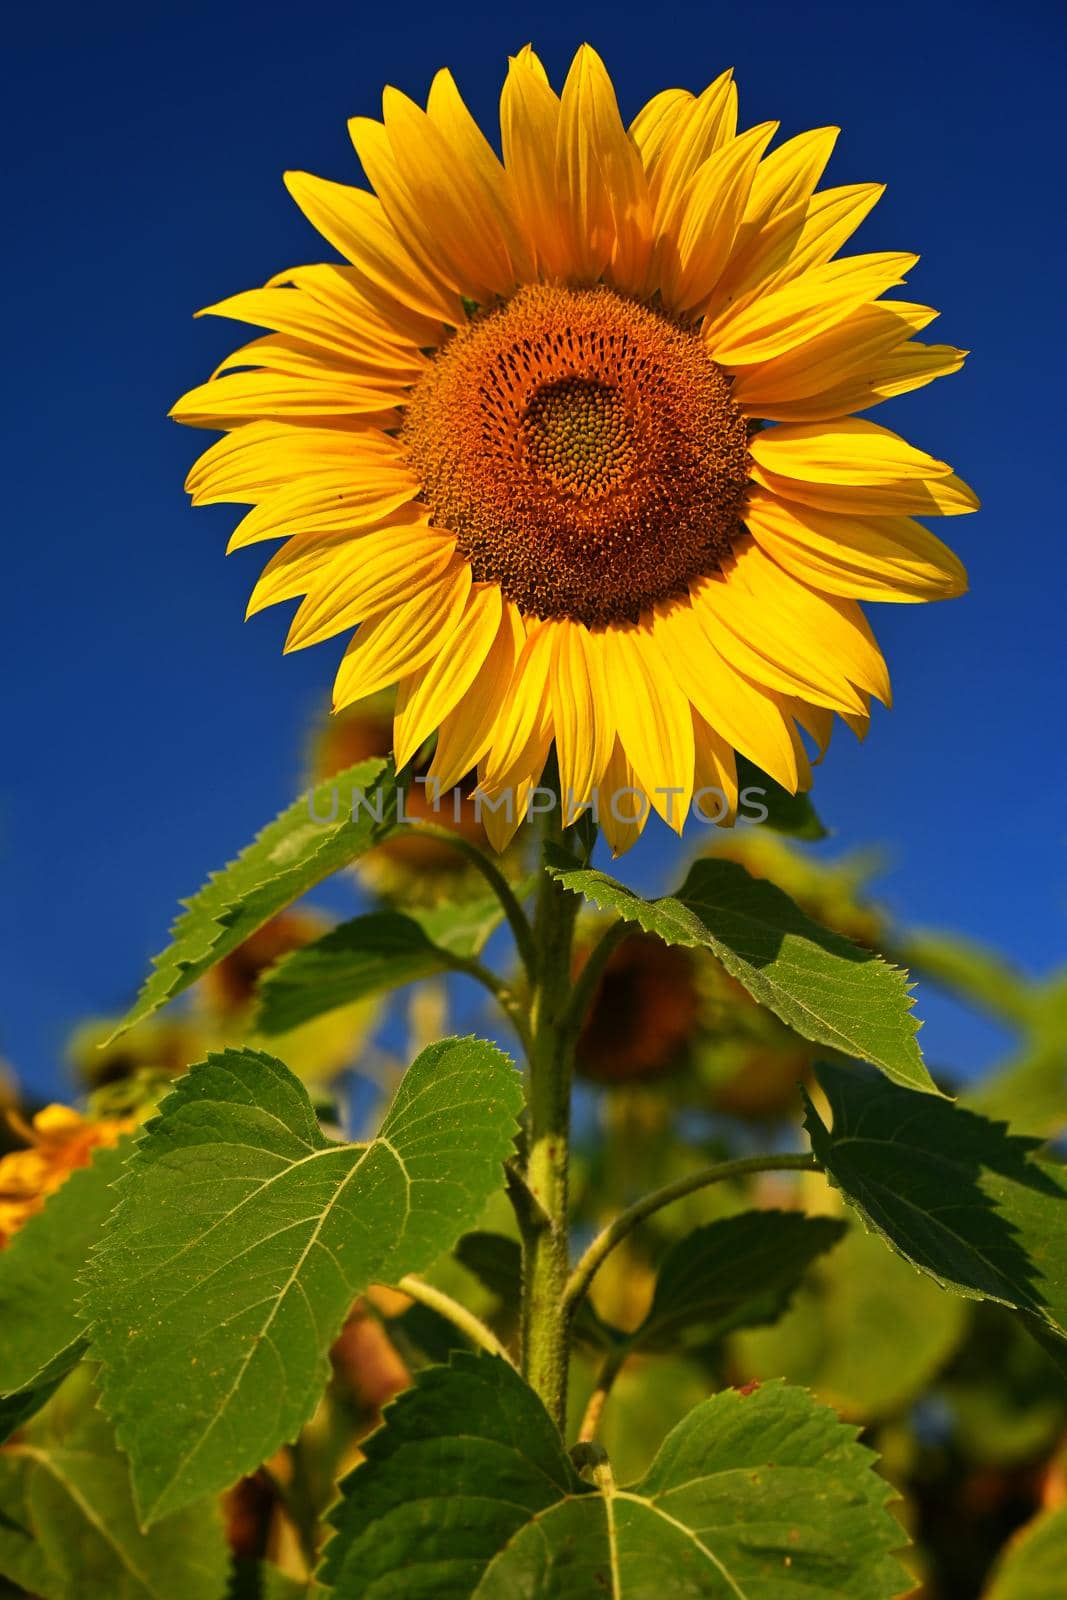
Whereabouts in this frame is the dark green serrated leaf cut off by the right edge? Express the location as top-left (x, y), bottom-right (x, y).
top-left (806, 1066), bottom-right (1067, 1338)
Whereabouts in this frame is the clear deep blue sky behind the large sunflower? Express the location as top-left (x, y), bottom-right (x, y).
top-left (0, 0), bottom-right (1067, 1088)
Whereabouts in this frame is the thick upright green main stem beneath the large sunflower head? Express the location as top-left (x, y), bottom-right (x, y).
top-left (522, 808), bottom-right (577, 1432)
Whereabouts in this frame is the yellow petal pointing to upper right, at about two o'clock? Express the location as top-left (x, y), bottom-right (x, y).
top-left (704, 253), bottom-right (918, 368)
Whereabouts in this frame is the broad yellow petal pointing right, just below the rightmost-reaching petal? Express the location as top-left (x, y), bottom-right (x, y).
top-left (744, 488), bottom-right (966, 600)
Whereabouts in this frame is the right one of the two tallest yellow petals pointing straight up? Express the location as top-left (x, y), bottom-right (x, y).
top-left (557, 45), bottom-right (651, 290)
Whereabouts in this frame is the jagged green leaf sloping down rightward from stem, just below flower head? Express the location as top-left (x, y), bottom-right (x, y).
top-left (549, 850), bottom-right (939, 1094)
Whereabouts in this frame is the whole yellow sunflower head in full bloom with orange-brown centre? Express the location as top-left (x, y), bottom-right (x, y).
top-left (173, 45), bottom-right (977, 851)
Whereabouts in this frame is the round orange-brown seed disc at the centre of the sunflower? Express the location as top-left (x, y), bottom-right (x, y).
top-left (403, 285), bottom-right (749, 626)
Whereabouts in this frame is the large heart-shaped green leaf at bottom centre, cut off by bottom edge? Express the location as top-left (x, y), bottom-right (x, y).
top-left (323, 1355), bottom-right (907, 1600)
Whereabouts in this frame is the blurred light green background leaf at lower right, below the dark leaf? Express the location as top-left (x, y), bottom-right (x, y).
top-left (729, 1224), bottom-right (969, 1424)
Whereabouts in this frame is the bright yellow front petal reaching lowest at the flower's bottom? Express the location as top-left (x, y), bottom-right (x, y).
top-left (597, 622), bottom-right (693, 832)
